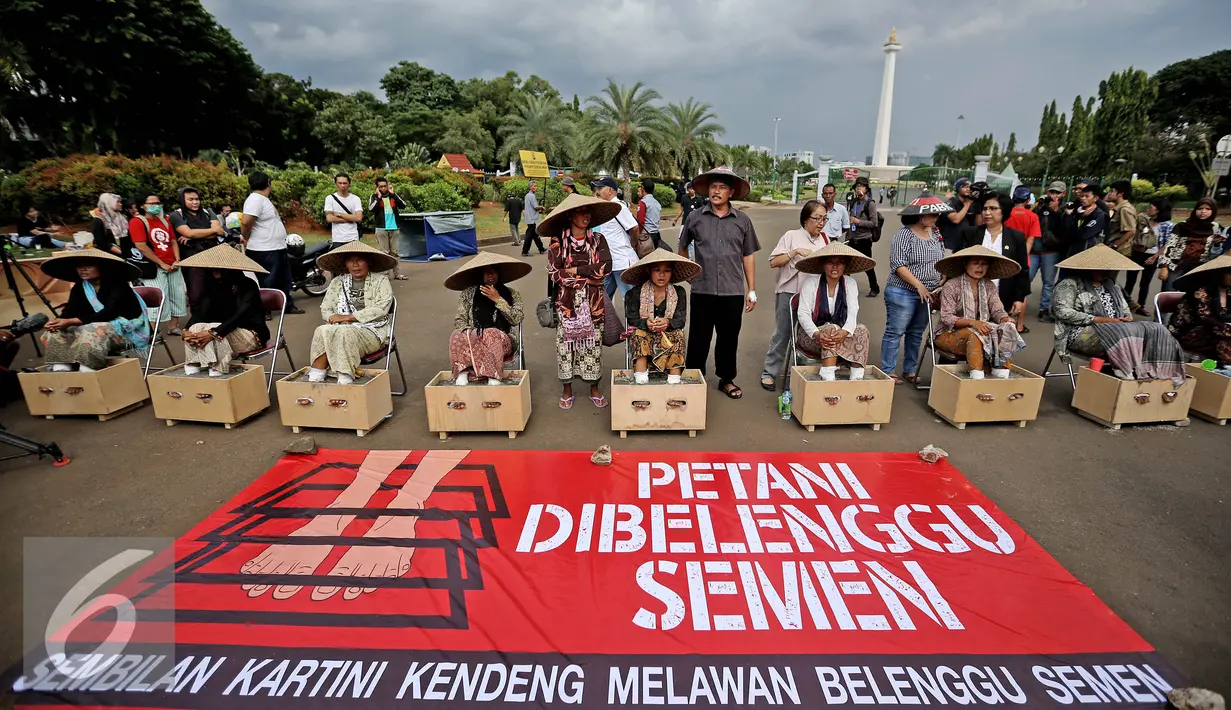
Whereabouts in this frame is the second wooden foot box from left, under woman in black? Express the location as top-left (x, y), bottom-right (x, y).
top-left (145, 364), bottom-right (270, 429)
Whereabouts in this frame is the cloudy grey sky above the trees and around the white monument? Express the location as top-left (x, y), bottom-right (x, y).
top-left (202, 0), bottom-right (1231, 160)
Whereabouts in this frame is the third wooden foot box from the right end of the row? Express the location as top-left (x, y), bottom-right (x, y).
top-left (927, 363), bottom-right (1045, 429)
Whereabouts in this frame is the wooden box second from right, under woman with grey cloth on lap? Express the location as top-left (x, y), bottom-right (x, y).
top-left (1073, 367), bottom-right (1197, 429)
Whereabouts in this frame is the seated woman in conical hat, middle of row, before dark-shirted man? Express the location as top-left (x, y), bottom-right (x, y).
top-left (620, 249), bottom-right (700, 385)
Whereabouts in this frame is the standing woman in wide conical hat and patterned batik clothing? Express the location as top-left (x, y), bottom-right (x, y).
top-left (546, 194), bottom-right (620, 410)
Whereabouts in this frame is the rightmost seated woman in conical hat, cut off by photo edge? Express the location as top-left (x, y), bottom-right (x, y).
top-left (1168, 255), bottom-right (1231, 367)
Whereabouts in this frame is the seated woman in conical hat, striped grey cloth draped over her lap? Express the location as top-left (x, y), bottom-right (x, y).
top-left (1051, 244), bottom-right (1184, 388)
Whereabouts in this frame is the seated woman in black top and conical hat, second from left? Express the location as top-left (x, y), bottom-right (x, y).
top-left (180, 244), bottom-right (270, 378)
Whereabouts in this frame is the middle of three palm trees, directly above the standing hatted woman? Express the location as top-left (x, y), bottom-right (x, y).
top-left (577, 79), bottom-right (667, 196)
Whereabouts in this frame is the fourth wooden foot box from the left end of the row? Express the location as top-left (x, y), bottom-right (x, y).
top-left (423, 370), bottom-right (531, 439)
